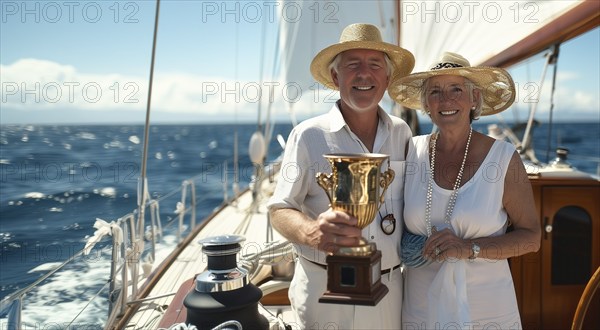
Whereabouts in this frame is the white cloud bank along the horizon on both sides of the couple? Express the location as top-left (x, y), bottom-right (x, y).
top-left (5, 59), bottom-right (600, 122)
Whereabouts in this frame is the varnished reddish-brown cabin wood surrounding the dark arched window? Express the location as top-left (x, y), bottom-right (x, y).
top-left (510, 177), bottom-right (600, 329)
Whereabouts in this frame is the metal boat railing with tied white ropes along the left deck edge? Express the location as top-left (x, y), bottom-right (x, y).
top-left (0, 177), bottom-right (207, 330)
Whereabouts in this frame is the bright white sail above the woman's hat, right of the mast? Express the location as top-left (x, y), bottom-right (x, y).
top-left (399, 0), bottom-right (582, 71)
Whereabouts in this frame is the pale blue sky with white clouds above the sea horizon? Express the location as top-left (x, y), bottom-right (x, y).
top-left (0, 0), bottom-right (600, 124)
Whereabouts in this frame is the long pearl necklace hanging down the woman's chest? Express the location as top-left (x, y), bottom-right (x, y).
top-left (425, 128), bottom-right (473, 237)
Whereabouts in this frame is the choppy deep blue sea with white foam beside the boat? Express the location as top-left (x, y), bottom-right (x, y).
top-left (0, 123), bottom-right (600, 329)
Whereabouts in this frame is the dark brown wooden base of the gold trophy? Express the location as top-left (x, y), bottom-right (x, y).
top-left (319, 250), bottom-right (389, 306)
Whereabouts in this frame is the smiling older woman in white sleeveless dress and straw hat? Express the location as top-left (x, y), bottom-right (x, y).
top-left (389, 53), bottom-right (541, 329)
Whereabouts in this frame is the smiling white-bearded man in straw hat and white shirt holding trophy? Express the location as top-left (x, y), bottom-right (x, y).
top-left (269, 24), bottom-right (414, 329)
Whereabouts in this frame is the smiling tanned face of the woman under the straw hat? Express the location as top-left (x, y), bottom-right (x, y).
top-left (425, 75), bottom-right (479, 128)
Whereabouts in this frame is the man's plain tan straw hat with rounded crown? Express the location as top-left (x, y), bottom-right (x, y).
top-left (310, 23), bottom-right (415, 90)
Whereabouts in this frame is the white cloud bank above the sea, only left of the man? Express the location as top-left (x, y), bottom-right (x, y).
top-left (0, 59), bottom-right (331, 121)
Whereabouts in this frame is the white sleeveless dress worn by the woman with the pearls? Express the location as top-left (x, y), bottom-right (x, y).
top-left (402, 135), bottom-right (522, 329)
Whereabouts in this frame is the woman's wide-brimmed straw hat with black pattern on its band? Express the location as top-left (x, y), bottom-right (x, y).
top-left (388, 52), bottom-right (515, 116)
